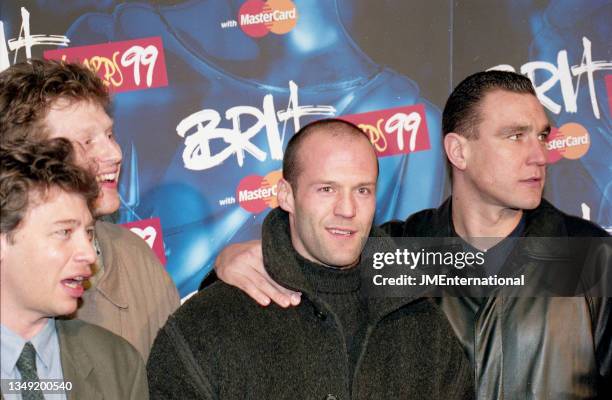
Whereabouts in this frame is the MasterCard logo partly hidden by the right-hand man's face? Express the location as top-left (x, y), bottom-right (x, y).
top-left (546, 122), bottom-right (591, 164)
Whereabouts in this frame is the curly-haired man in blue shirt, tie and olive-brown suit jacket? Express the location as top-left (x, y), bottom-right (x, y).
top-left (0, 139), bottom-right (148, 400)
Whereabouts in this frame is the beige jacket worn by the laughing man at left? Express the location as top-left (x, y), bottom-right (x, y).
top-left (76, 221), bottom-right (180, 362)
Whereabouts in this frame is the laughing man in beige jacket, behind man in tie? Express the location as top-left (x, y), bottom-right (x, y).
top-left (0, 60), bottom-right (179, 360)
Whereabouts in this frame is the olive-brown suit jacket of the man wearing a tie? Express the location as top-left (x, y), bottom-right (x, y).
top-left (56, 320), bottom-right (149, 400)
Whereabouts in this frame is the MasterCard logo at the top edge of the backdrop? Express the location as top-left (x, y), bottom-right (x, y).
top-left (238, 0), bottom-right (298, 38)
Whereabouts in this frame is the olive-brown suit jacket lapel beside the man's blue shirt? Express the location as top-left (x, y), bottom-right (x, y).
top-left (56, 320), bottom-right (103, 400)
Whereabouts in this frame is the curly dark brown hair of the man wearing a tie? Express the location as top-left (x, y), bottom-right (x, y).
top-left (0, 138), bottom-right (99, 242)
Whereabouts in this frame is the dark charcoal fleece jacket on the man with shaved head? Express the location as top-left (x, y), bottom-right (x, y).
top-left (148, 209), bottom-right (474, 400)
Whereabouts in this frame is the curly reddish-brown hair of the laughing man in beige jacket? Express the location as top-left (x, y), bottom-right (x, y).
top-left (0, 59), bottom-right (110, 142)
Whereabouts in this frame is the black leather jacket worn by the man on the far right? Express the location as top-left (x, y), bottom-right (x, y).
top-left (383, 199), bottom-right (612, 400)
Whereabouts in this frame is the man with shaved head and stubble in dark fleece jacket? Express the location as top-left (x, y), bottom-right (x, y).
top-left (147, 120), bottom-right (473, 399)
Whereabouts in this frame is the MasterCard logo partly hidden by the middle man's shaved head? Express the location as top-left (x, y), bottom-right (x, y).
top-left (236, 170), bottom-right (283, 214)
